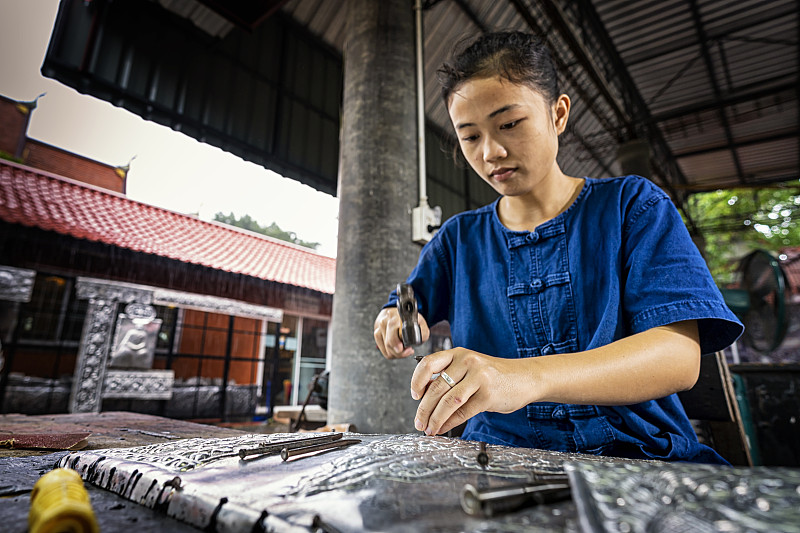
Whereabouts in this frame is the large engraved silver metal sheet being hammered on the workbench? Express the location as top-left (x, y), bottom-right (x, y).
top-left (60, 433), bottom-right (636, 532)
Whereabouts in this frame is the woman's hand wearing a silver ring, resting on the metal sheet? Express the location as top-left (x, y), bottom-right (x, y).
top-left (411, 348), bottom-right (532, 435)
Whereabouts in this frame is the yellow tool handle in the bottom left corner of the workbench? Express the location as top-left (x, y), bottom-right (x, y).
top-left (28, 468), bottom-right (100, 533)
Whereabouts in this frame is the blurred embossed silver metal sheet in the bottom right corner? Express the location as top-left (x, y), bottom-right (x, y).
top-left (566, 461), bottom-right (800, 533)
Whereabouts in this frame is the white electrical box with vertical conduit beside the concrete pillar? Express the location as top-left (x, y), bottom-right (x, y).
top-left (411, 0), bottom-right (442, 244)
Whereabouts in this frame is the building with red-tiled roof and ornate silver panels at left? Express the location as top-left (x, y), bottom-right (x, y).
top-left (0, 94), bottom-right (335, 420)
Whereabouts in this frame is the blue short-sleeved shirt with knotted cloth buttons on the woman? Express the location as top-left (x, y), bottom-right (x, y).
top-left (387, 176), bottom-right (743, 463)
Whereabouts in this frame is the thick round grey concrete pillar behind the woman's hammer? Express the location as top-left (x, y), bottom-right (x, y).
top-left (328, 0), bottom-right (420, 433)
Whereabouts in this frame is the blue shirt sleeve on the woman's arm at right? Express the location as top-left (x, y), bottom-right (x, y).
top-left (623, 186), bottom-right (744, 353)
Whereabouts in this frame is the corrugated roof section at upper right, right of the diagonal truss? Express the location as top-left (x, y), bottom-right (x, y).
top-left (594, 0), bottom-right (800, 193)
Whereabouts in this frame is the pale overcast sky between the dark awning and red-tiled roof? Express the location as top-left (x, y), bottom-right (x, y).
top-left (0, 0), bottom-right (339, 257)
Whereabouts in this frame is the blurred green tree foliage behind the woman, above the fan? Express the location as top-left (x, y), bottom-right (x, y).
top-left (688, 182), bottom-right (800, 285)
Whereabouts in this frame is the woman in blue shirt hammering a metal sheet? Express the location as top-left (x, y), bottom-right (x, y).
top-left (375, 32), bottom-right (743, 464)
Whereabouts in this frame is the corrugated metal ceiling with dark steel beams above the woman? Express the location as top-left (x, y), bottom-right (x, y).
top-left (51, 0), bottom-right (800, 225)
